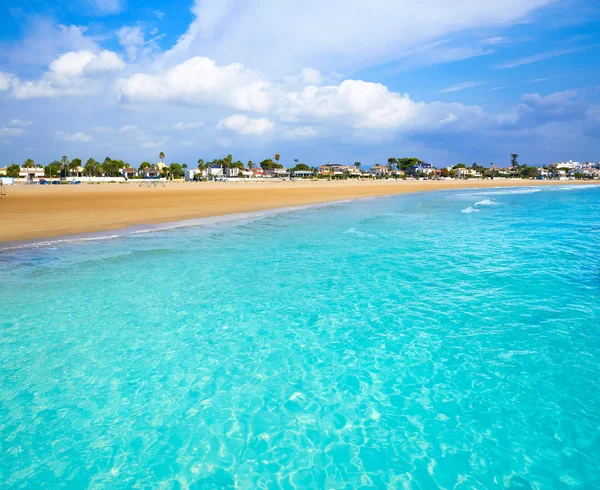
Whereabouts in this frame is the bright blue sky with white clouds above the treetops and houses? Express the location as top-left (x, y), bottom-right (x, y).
top-left (0, 0), bottom-right (600, 167)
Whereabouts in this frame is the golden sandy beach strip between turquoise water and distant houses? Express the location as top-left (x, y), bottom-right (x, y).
top-left (0, 180), bottom-right (586, 243)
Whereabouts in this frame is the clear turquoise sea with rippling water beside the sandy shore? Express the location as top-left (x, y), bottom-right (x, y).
top-left (0, 186), bottom-right (600, 489)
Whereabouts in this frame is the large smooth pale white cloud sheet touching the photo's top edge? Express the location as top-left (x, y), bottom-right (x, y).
top-left (169, 0), bottom-right (553, 75)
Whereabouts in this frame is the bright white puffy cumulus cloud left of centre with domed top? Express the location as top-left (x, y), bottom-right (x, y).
top-left (118, 56), bottom-right (269, 112)
